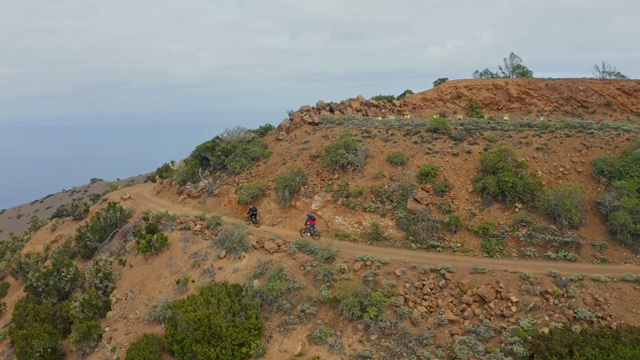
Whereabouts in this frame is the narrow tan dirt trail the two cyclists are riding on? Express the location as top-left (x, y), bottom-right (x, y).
top-left (124, 183), bottom-right (640, 276)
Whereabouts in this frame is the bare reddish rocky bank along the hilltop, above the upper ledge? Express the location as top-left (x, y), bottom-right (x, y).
top-left (281, 78), bottom-right (640, 130)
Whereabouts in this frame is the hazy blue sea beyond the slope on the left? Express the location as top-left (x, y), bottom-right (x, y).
top-left (0, 116), bottom-right (255, 209)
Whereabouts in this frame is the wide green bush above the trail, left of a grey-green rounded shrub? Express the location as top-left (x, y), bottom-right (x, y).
top-left (474, 145), bottom-right (544, 205)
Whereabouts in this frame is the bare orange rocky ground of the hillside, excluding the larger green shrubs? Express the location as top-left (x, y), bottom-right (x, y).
top-left (0, 79), bottom-right (640, 360)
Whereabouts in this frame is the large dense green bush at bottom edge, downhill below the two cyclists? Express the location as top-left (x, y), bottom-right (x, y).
top-left (165, 282), bottom-right (264, 360)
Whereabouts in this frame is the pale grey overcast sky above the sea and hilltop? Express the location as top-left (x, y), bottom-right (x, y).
top-left (0, 0), bottom-right (640, 126)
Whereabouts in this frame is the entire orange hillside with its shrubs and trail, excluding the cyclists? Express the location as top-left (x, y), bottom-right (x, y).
top-left (0, 79), bottom-right (640, 359)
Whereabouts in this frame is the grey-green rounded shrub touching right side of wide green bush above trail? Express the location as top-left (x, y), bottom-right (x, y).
top-left (542, 184), bottom-right (587, 229)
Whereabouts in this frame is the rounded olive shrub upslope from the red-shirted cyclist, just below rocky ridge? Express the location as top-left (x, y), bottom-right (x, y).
top-left (321, 131), bottom-right (367, 171)
